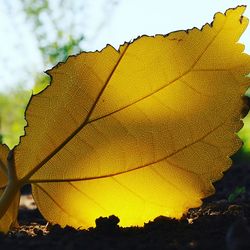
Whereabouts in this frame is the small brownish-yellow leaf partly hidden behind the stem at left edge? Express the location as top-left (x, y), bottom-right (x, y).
top-left (0, 144), bottom-right (20, 233)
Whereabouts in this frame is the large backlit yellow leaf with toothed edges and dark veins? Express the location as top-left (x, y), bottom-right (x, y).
top-left (15, 6), bottom-right (250, 227)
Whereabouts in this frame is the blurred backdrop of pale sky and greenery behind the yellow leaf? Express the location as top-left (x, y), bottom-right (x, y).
top-left (0, 0), bottom-right (250, 155)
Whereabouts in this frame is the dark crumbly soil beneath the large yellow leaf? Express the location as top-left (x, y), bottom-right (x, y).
top-left (0, 152), bottom-right (250, 250)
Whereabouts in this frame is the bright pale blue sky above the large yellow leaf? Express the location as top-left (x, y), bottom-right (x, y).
top-left (0, 0), bottom-right (250, 91)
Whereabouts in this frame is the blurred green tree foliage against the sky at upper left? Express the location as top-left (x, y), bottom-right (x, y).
top-left (22, 0), bottom-right (84, 66)
